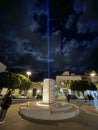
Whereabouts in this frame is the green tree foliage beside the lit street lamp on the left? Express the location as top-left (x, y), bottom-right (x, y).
top-left (0, 72), bottom-right (31, 90)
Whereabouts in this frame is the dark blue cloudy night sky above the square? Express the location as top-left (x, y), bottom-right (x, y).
top-left (0, 0), bottom-right (98, 79)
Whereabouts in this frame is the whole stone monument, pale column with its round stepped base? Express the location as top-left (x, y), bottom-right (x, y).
top-left (19, 78), bottom-right (79, 121)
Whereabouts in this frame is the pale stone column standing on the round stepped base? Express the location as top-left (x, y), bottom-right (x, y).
top-left (43, 79), bottom-right (55, 104)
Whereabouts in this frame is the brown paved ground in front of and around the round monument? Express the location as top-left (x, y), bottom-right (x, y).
top-left (0, 99), bottom-right (98, 130)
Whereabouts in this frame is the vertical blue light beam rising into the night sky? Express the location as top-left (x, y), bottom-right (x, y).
top-left (46, 0), bottom-right (50, 78)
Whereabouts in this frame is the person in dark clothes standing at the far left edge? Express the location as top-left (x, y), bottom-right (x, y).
top-left (0, 90), bottom-right (12, 124)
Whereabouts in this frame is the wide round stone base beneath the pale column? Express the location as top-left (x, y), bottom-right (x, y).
top-left (19, 101), bottom-right (79, 121)
